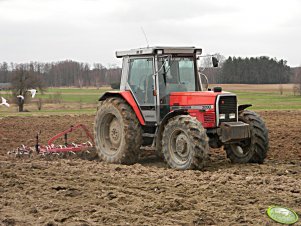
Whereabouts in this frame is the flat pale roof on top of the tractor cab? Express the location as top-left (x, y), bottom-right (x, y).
top-left (116, 46), bottom-right (202, 58)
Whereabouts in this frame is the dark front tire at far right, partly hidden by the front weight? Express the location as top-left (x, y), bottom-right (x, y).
top-left (224, 110), bottom-right (269, 163)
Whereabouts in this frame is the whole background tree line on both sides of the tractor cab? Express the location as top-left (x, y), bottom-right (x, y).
top-left (0, 57), bottom-right (299, 88)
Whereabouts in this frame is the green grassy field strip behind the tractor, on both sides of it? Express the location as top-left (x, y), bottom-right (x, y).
top-left (0, 85), bottom-right (301, 116)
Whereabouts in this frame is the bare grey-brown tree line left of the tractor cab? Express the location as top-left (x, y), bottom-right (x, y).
top-left (0, 60), bottom-right (121, 88)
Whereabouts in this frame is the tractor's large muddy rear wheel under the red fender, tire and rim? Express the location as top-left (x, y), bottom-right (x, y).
top-left (94, 97), bottom-right (142, 164)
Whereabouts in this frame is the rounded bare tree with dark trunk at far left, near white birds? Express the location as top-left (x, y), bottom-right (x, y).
top-left (11, 63), bottom-right (44, 112)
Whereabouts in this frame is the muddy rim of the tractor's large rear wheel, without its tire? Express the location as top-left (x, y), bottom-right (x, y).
top-left (99, 114), bottom-right (122, 155)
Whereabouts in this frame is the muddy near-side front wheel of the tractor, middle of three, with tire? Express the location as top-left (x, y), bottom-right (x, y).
top-left (162, 115), bottom-right (209, 170)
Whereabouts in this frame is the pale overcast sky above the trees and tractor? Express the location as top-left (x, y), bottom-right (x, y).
top-left (0, 0), bottom-right (301, 66)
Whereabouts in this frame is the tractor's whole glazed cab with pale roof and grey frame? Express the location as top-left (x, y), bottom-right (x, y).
top-left (116, 47), bottom-right (216, 123)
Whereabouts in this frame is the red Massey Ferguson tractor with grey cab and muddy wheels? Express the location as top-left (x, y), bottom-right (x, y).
top-left (94, 47), bottom-right (269, 170)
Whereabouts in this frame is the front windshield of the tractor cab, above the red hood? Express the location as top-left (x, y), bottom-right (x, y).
top-left (158, 56), bottom-right (197, 97)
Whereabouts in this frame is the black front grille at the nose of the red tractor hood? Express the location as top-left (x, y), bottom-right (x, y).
top-left (217, 96), bottom-right (237, 122)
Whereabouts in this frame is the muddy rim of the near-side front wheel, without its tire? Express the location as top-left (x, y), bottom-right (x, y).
top-left (168, 130), bottom-right (190, 165)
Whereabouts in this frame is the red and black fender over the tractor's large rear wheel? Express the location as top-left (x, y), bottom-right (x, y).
top-left (98, 91), bottom-right (145, 126)
